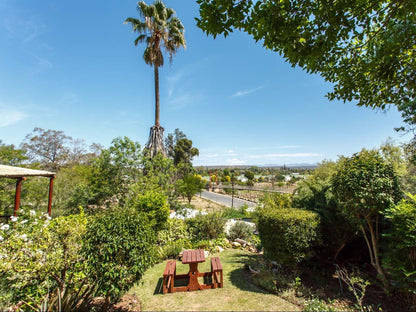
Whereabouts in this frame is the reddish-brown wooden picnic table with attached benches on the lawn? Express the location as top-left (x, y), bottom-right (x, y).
top-left (163, 249), bottom-right (224, 294)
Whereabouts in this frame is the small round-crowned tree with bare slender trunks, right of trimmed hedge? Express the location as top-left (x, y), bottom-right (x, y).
top-left (332, 150), bottom-right (401, 282)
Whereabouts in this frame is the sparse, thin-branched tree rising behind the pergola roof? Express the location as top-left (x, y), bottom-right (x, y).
top-left (21, 127), bottom-right (72, 170)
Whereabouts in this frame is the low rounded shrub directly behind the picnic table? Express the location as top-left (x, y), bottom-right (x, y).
top-left (186, 212), bottom-right (226, 240)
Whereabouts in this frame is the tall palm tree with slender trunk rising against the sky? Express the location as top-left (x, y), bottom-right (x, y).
top-left (124, 0), bottom-right (186, 157)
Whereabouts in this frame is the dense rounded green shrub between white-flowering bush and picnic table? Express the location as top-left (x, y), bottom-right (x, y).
top-left (83, 208), bottom-right (157, 310)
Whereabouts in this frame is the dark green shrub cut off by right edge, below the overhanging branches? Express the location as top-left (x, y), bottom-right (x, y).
top-left (384, 194), bottom-right (416, 307)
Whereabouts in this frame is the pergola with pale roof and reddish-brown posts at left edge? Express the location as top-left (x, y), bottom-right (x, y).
top-left (0, 165), bottom-right (56, 216)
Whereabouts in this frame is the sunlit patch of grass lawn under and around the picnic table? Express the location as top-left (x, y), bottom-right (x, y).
top-left (129, 249), bottom-right (300, 311)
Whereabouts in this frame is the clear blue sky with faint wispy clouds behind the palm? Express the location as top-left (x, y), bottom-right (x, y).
top-left (0, 0), bottom-right (410, 165)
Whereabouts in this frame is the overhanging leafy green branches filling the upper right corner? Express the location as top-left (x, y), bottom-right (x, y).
top-left (197, 0), bottom-right (416, 110)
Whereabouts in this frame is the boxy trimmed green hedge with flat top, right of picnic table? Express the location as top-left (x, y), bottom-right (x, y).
top-left (258, 208), bottom-right (319, 267)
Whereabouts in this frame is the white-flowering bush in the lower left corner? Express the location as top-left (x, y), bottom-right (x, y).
top-left (0, 209), bottom-right (86, 310)
